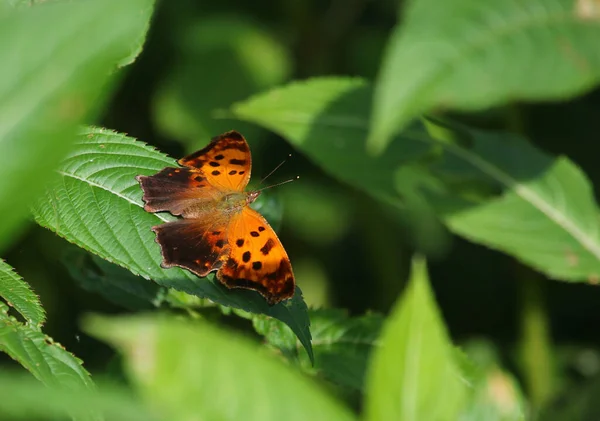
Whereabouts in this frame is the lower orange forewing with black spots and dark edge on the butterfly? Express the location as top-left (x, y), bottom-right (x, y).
top-left (217, 206), bottom-right (295, 305)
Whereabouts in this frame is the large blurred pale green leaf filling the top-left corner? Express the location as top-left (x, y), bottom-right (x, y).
top-left (0, 0), bottom-right (157, 249)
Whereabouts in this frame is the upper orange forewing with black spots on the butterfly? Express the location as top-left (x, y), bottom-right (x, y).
top-left (177, 130), bottom-right (252, 192)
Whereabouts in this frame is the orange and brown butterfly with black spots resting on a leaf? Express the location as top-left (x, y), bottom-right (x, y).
top-left (136, 131), bottom-right (295, 305)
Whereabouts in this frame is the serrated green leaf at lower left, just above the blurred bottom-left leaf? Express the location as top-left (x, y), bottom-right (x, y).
top-left (0, 302), bottom-right (93, 389)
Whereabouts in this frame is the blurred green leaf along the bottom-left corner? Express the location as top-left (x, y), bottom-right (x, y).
top-left (0, 370), bottom-right (158, 421)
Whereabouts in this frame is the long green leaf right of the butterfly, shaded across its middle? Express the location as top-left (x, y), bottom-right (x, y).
top-left (232, 78), bottom-right (600, 281)
